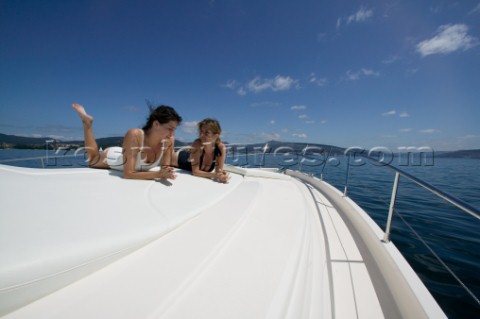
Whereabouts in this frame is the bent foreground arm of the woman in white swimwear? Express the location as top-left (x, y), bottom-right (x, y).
top-left (122, 129), bottom-right (175, 179)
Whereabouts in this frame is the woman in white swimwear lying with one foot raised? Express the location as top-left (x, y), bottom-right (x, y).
top-left (72, 104), bottom-right (182, 179)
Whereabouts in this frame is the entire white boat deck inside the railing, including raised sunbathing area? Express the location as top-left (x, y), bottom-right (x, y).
top-left (0, 166), bottom-right (412, 319)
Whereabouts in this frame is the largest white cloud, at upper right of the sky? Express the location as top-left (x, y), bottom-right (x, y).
top-left (417, 24), bottom-right (478, 57)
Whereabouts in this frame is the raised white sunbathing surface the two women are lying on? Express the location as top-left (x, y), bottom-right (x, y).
top-left (0, 165), bottom-right (242, 314)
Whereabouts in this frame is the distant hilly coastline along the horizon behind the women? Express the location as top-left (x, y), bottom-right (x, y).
top-left (0, 133), bottom-right (480, 159)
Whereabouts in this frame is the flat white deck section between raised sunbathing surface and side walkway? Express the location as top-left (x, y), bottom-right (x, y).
top-left (0, 172), bottom-right (330, 318)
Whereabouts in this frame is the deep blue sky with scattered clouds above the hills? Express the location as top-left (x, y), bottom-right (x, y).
top-left (0, 0), bottom-right (480, 150)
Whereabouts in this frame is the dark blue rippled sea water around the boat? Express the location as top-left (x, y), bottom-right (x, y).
top-left (0, 150), bottom-right (480, 318)
